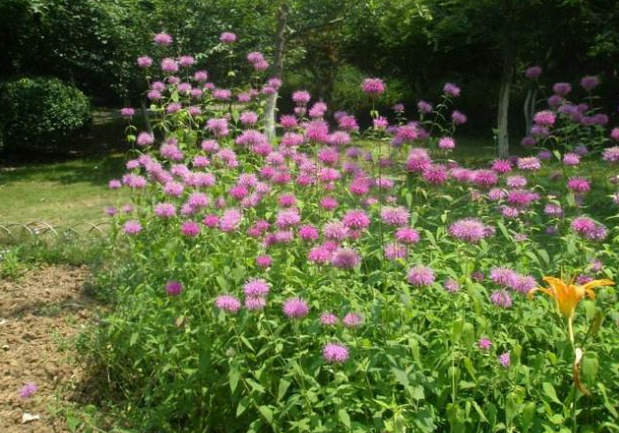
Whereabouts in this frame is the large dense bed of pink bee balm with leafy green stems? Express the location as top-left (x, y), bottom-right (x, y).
top-left (86, 33), bottom-right (619, 432)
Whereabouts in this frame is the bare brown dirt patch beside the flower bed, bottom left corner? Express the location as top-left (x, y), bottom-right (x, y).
top-left (0, 266), bottom-right (95, 433)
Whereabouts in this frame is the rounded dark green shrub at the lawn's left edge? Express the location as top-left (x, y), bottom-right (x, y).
top-left (0, 78), bottom-right (90, 152)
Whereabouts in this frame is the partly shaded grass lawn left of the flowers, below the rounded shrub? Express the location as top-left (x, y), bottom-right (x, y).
top-left (0, 112), bottom-right (125, 227)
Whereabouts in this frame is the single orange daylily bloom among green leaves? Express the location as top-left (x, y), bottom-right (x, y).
top-left (529, 277), bottom-right (615, 320)
